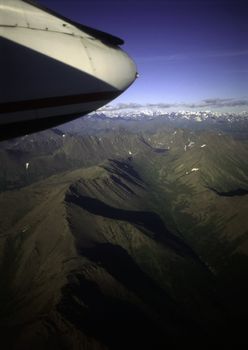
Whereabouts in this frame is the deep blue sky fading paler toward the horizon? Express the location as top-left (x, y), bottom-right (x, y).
top-left (39, 0), bottom-right (248, 109)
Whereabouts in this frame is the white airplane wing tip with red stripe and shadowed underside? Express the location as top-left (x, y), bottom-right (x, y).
top-left (0, 0), bottom-right (137, 139)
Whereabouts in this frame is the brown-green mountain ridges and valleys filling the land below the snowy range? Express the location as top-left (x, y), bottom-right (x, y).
top-left (0, 117), bottom-right (248, 350)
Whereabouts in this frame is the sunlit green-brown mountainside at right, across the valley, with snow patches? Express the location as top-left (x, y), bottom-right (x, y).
top-left (134, 130), bottom-right (248, 258)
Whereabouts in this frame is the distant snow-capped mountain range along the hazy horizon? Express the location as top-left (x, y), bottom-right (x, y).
top-left (59, 107), bottom-right (248, 137)
